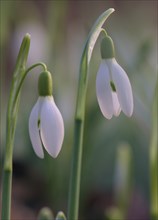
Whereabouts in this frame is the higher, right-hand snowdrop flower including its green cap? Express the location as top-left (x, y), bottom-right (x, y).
top-left (96, 36), bottom-right (133, 119)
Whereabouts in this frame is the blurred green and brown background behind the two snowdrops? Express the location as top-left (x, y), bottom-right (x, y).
top-left (0, 0), bottom-right (158, 220)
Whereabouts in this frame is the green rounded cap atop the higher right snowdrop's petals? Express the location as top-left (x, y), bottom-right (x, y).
top-left (101, 35), bottom-right (115, 59)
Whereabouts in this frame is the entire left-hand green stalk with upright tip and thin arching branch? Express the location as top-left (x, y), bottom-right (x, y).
top-left (1, 34), bottom-right (46, 220)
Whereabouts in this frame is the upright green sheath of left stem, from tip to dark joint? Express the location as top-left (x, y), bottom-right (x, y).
top-left (5, 34), bottom-right (30, 170)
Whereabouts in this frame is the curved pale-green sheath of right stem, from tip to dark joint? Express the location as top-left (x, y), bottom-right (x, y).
top-left (76, 8), bottom-right (115, 119)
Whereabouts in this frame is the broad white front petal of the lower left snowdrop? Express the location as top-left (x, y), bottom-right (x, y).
top-left (40, 96), bottom-right (64, 158)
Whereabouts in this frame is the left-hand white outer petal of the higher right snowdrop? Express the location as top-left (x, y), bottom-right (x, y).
top-left (96, 60), bottom-right (113, 119)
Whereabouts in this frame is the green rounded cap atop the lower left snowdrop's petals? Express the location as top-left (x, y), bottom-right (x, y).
top-left (38, 71), bottom-right (53, 96)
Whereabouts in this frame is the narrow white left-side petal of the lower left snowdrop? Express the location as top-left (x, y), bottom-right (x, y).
top-left (29, 99), bottom-right (44, 158)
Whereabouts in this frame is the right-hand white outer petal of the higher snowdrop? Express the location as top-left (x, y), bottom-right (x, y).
top-left (110, 59), bottom-right (133, 117)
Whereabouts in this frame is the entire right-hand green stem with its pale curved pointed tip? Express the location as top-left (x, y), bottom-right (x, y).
top-left (68, 8), bottom-right (114, 220)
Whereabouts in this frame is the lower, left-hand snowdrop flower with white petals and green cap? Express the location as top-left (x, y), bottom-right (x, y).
top-left (29, 71), bottom-right (64, 158)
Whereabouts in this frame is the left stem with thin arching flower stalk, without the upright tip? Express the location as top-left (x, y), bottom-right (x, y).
top-left (2, 60), bottom-right (46, 220)
